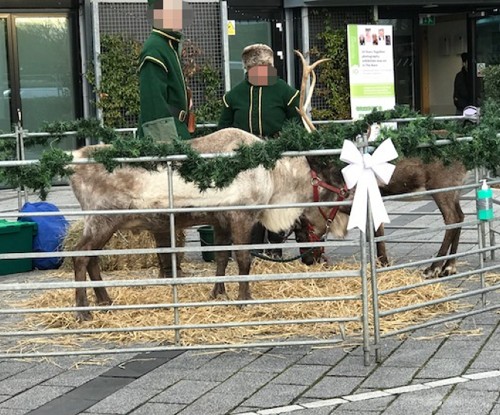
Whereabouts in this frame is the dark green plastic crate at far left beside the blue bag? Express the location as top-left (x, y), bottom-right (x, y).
top-left (0, 219), bottom-right (37, 275)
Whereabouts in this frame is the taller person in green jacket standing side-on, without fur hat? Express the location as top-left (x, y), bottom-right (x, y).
top-left (137, 0), bottom-right (193, 142)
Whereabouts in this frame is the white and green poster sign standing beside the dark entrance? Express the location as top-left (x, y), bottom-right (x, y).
top-left (347, 25), bottom-right (396, 119)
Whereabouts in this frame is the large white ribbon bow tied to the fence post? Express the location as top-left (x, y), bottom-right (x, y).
top-left (340, 139), bottom-right (398, 232)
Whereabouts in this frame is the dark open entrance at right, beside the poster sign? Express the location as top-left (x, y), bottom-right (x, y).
top-left (378, 4), bottom-right (500, 115)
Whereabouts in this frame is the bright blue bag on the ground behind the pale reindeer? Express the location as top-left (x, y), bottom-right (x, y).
top-left (18, 202), bottom-right (68, 269)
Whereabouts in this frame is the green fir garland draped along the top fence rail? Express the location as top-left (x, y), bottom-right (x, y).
top-left (0, 101), bottom-right (500, 199)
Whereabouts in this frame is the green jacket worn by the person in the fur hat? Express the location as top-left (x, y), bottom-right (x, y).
top-left (218, 78), bottom-right (300, 137)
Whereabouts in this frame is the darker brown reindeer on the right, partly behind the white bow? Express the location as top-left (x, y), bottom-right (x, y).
top-left (295, 51), bottom-right (467, 278)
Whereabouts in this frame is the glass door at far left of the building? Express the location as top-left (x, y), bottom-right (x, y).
top-left (0, 12), bottom-right (81, 157)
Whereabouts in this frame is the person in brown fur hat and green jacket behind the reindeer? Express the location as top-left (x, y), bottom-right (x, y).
top-left (218, 43), bottom-right (300, 256)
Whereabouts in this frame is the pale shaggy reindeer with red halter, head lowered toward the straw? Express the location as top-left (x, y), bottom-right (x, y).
top-left (71, 128), bottom-right (346, 320)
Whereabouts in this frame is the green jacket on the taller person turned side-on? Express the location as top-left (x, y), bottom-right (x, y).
top-left (137, 29), bottom-right (191, 142)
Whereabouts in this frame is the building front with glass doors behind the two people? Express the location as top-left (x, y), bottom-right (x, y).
top-left (0, 0), bottom-right (500, 142)
